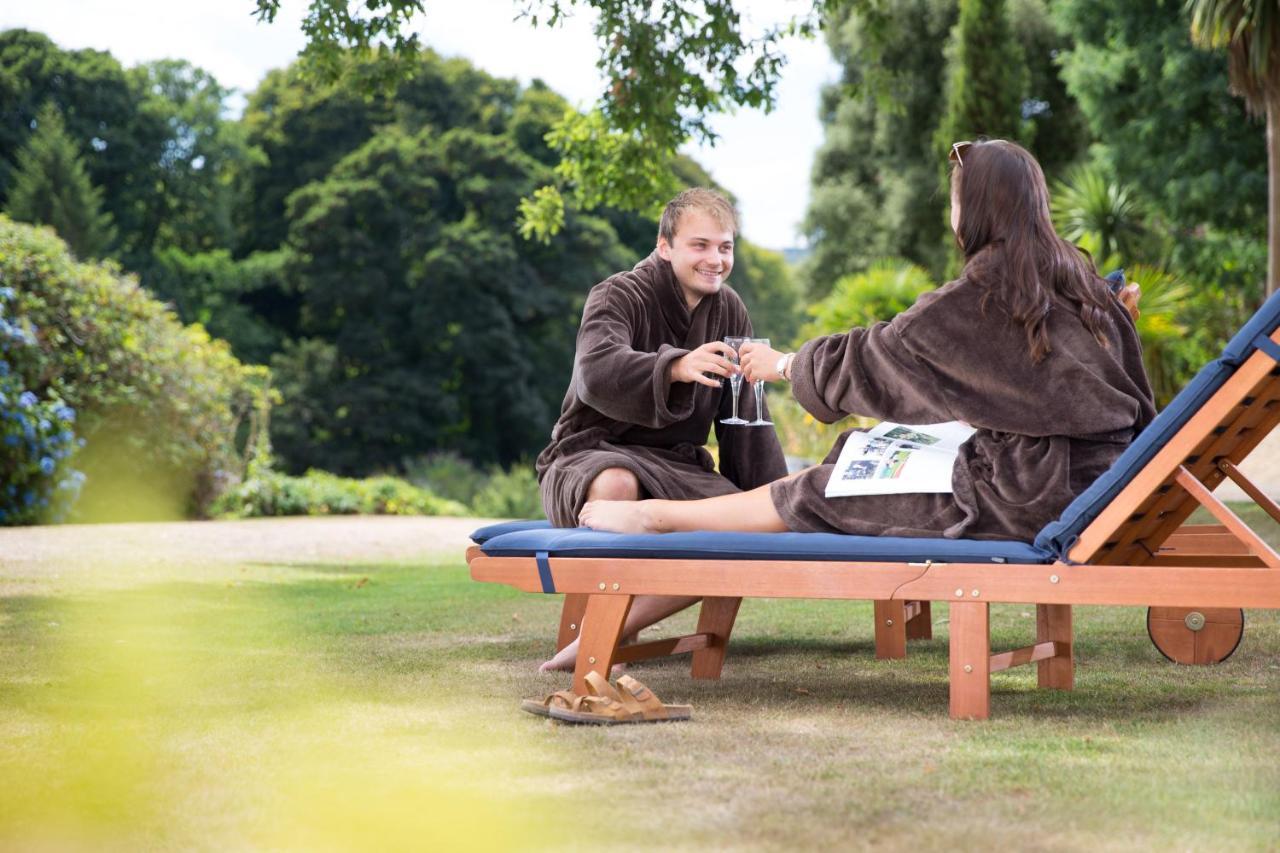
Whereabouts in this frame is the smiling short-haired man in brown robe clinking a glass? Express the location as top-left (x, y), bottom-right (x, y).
top-left (538, 188), bottom-right (786, 671)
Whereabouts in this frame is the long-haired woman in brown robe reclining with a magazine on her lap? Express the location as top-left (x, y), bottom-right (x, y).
top-left (580, 140), bottom-right (1155, 537)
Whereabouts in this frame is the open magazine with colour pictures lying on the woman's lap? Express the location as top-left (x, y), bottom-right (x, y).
top-left (827, 420), bottom-right (975, 497)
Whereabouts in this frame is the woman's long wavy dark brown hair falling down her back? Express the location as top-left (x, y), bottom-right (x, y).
top-left (951, 140), bottom-right (1112, 362)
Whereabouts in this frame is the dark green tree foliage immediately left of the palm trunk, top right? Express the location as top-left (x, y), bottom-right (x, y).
top-left (1055, 0), bottom-right (1267, 233)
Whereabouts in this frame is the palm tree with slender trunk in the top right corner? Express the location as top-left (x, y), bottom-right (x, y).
top-left (1187, 0), bottom-right (1280, 296)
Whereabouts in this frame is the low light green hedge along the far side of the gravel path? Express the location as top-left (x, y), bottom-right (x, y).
top-left (212, 467), bottom-right (467, 519)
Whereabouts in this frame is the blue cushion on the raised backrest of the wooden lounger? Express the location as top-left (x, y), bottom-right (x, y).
top-left (1036, 293), bottom-right (1280, 558)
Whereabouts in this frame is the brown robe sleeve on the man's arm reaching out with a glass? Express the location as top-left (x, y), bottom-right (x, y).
top-left (573, 279), bottom-right (694, 429)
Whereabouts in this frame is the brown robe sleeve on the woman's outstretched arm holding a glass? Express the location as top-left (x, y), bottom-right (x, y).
top-left (791, 315), bottom-right (957, 424)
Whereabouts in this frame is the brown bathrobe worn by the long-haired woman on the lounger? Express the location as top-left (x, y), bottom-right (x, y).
top-left (769, 278), bottom-right (1155, 540)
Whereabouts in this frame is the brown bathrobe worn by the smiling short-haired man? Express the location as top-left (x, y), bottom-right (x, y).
top-left (538, 252), bottom-right (786, 528)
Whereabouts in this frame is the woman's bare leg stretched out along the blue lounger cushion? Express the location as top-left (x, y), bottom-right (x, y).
top-left (577, 485), bottom-right (787, 533)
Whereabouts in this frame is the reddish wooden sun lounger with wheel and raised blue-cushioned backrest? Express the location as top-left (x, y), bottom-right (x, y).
top-left (467, 297), bottom-right (1280, 719)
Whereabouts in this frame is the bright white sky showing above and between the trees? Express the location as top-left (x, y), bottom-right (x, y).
top-left (0, 0), bottom-right (840, 248)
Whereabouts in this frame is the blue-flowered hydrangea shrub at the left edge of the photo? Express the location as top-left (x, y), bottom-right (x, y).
top-left (0, 287), bottom-right (84, 524)
